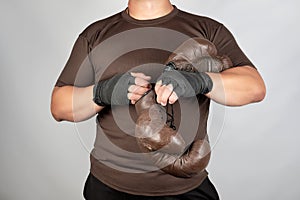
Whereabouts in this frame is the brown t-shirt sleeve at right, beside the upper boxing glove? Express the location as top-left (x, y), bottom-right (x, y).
top-left (211, 24), bottom-right (255, 68)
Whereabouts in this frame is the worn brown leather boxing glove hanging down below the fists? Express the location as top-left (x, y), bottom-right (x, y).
top-left (135, 90), bottom-right (210, 178)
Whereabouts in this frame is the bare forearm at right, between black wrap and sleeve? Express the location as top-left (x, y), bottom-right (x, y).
top-left (206, 66), bottom-right (266, 106)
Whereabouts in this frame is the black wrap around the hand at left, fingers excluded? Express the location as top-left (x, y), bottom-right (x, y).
top-left (93, 73), bottom-right (135, 106)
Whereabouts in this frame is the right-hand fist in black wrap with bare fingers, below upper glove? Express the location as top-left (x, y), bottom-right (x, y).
top-left (155, 66), bottom-right (213, 106)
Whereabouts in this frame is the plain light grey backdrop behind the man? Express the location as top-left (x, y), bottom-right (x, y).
top-left (0, 0), bottom-right (300, 200)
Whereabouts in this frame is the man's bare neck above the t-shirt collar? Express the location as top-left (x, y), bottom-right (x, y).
top-left (128, 0), bottom-right (173, 20)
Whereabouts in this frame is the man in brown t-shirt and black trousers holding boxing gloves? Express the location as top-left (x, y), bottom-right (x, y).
top-left (51, 0), bottom-right (265, 200)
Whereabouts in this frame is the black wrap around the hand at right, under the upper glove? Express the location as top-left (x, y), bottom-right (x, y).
top-left (157, 62), bottom-right (213, 97)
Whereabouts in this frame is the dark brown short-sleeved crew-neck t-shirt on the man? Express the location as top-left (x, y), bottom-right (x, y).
top-left (56, 7), bottom-right (253, 196)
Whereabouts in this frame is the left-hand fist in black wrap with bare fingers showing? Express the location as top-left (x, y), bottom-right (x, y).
top-left (93, 73), bottom-right (151, 106)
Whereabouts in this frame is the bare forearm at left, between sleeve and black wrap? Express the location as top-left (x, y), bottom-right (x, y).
top-left (51, 86), bottom-right (103, 122)
